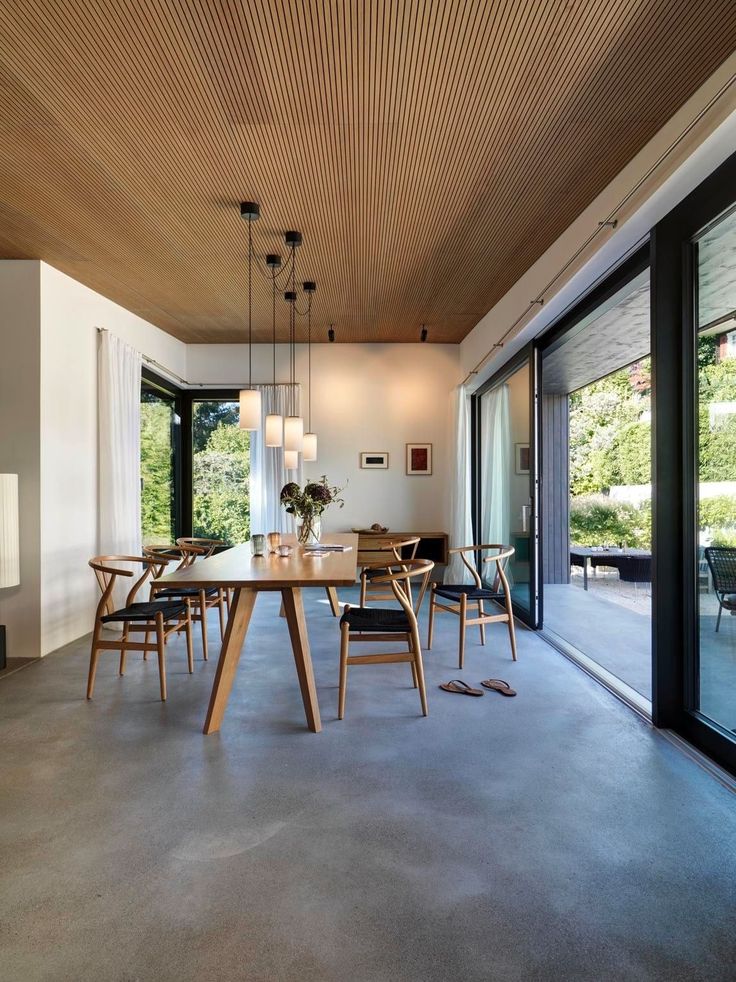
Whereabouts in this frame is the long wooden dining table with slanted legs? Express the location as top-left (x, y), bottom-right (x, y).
top-left (155, 533), bottom-right (358, 733)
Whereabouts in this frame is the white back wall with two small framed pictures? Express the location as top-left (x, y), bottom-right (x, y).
top-left (187, 343), bottom-right (460, 532)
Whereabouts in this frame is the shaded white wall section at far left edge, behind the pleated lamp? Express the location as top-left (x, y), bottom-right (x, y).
top-left (0, 260), bottom-right (41, 658)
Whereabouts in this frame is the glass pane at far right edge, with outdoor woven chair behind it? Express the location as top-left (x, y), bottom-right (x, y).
top-left (693, 206), bottom-right (736, 730)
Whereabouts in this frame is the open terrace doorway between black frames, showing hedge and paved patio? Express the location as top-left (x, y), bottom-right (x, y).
top-left (540, 255), bottom-right (652, 712)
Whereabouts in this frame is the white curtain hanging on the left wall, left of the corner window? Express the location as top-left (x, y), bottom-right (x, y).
top-left (97, 331), bottom-right (141, 556)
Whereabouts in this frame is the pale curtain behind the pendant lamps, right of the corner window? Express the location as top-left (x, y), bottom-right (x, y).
top-left (250, 385), bottom-right (302, 535)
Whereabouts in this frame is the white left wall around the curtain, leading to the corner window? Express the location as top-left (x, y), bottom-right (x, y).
top-left (37, 263), bottom-right (186, 654)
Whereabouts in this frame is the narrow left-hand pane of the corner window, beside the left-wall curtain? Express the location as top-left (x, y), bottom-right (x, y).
top-left (141, 377), bottom-right (180, 545)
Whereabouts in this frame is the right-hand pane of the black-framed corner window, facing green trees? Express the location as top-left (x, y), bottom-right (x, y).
top-left (191, 398), bottom-right (250, 545)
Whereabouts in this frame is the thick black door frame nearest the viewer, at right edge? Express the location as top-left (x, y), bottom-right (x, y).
top-left (652, 146), bottom-right (736, 774)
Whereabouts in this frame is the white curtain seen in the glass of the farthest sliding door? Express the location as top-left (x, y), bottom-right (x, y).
top-left (480, 385), bottom-right (513, 545)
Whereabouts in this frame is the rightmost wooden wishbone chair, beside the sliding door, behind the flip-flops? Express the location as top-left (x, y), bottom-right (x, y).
top-left (427, 545), bottom-right (516, 668)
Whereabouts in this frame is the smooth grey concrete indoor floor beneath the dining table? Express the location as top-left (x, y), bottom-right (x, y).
top-left (0, 591), bottom-right (736, 982)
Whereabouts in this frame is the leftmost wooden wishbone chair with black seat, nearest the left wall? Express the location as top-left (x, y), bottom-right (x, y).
top-left (87, 556), bottom-right (194, 702)
